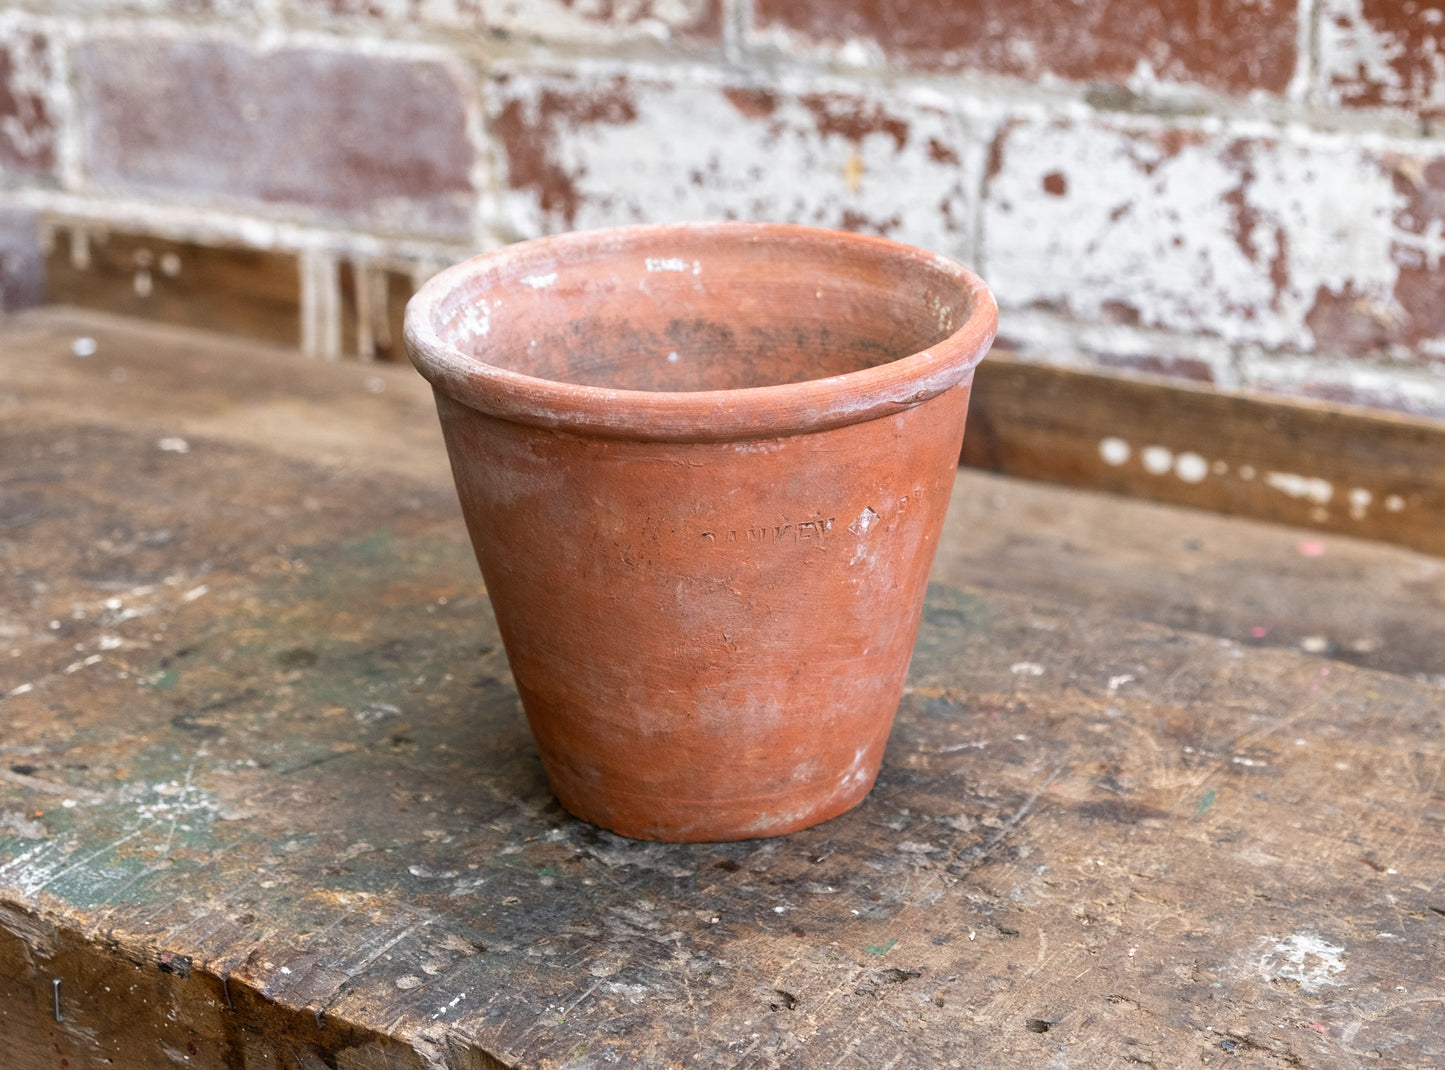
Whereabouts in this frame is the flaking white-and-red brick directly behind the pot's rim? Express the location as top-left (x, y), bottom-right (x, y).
top-left (488, 69), bottom-right (984, 259)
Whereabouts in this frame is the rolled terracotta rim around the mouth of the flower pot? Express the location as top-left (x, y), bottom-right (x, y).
top-left (405, 223), bottom-right (998, 442)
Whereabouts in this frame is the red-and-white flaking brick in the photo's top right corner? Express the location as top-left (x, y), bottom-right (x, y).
top-left (1319, 0), bottom-right (1445, 116)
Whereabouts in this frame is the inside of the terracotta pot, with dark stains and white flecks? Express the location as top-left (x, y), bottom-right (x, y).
top-left (421, 227), bottom-right (972, 392)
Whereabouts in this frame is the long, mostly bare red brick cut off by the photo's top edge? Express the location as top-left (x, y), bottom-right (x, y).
top-left (754, 0), bottom-right (1298, 93)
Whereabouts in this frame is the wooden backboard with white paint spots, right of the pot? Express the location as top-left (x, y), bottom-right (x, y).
top-left (962, 353), bottom-right (1445, 554)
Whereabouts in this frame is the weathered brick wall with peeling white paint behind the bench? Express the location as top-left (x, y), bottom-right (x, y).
top-left (0, 0), bottom-right (1445, 418)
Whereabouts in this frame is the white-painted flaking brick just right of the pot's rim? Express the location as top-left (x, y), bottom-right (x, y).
top-left (984, 123), bottom-right (1399, 350)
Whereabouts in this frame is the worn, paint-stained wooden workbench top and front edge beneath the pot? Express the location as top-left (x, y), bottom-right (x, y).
top-left (0, 309), bottom-right (1445, 1070)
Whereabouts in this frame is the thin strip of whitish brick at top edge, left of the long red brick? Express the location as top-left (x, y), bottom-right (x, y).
top-left (289, 0), bottom-right (723, 43)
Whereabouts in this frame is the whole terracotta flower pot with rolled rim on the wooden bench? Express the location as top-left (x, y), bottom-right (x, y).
top-left (406, 224), bottom-right (997, 842)
